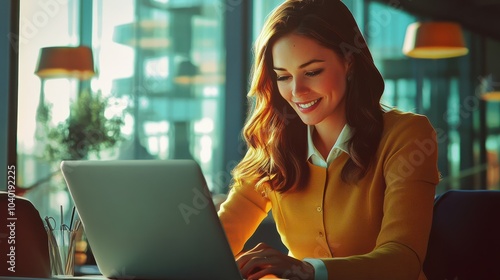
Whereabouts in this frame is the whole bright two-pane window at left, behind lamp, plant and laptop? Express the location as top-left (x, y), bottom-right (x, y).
top-left (18, 0), bottom-right (226, 221)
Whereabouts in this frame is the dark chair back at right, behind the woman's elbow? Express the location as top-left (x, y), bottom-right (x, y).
top-left (423, 190), bottom-right (500, 280)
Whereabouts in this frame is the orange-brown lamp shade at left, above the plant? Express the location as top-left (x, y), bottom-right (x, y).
top-left (35, 46), bottom-right (95, 80)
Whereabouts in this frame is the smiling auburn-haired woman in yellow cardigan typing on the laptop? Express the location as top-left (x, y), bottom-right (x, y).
top-left (219, 0), bottom-right (439, 280)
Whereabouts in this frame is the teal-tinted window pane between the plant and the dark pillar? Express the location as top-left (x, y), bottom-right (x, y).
top-left (93, 0), bottom-right (226, 192)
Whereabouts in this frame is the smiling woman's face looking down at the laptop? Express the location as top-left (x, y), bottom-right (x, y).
top-left (272, 34), bottom-right (348, 128)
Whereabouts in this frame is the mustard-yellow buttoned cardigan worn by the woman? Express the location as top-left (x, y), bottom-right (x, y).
top-left (219, 110), bottom-right (439, 280)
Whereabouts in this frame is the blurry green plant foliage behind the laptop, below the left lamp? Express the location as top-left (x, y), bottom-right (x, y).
top-left (44, 88), bottom-right (123, 161)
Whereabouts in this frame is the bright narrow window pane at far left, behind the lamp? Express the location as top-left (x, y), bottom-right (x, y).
top-left (16, 0), bottom-right (77, 221)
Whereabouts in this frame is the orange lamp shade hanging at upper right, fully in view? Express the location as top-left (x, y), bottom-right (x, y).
top-left (403, 22), bottom-right (469, 59)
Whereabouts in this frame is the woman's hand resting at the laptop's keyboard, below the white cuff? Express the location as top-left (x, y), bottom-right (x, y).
top-left (236, 243), bottom-right (314, 280)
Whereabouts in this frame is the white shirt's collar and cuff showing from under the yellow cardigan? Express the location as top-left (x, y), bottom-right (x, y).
top-left (304, 124), bottom-right (351, 280)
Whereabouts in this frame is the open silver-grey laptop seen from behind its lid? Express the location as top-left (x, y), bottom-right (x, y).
top-left (61, 160), bottom-right (242, 280)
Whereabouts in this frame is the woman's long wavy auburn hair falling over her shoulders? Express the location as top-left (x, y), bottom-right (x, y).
top-left (229, 0), bottom-right (384, 193)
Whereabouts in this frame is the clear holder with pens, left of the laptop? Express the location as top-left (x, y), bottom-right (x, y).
top-left (47, 229), bottom-right (76, 276)
